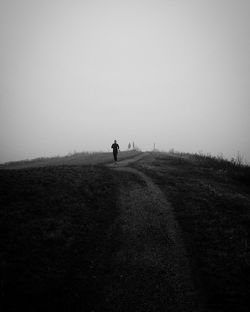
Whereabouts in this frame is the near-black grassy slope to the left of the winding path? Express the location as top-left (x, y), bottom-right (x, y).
top-left (0, 166), bottom-right (124, 311)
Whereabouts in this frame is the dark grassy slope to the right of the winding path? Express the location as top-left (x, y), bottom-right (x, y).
top-left (134, 153), bottom-right (250, 312)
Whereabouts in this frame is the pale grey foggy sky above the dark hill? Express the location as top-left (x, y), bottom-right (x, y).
top-left (0, 0), bottom-right (250, 162)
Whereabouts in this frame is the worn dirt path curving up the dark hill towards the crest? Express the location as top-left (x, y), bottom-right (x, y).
top-left (104, 153), bottom-right (203, 312)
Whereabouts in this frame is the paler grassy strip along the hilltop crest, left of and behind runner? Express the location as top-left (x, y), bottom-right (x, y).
top-left (0, 150), bottom-right (140, 169)
